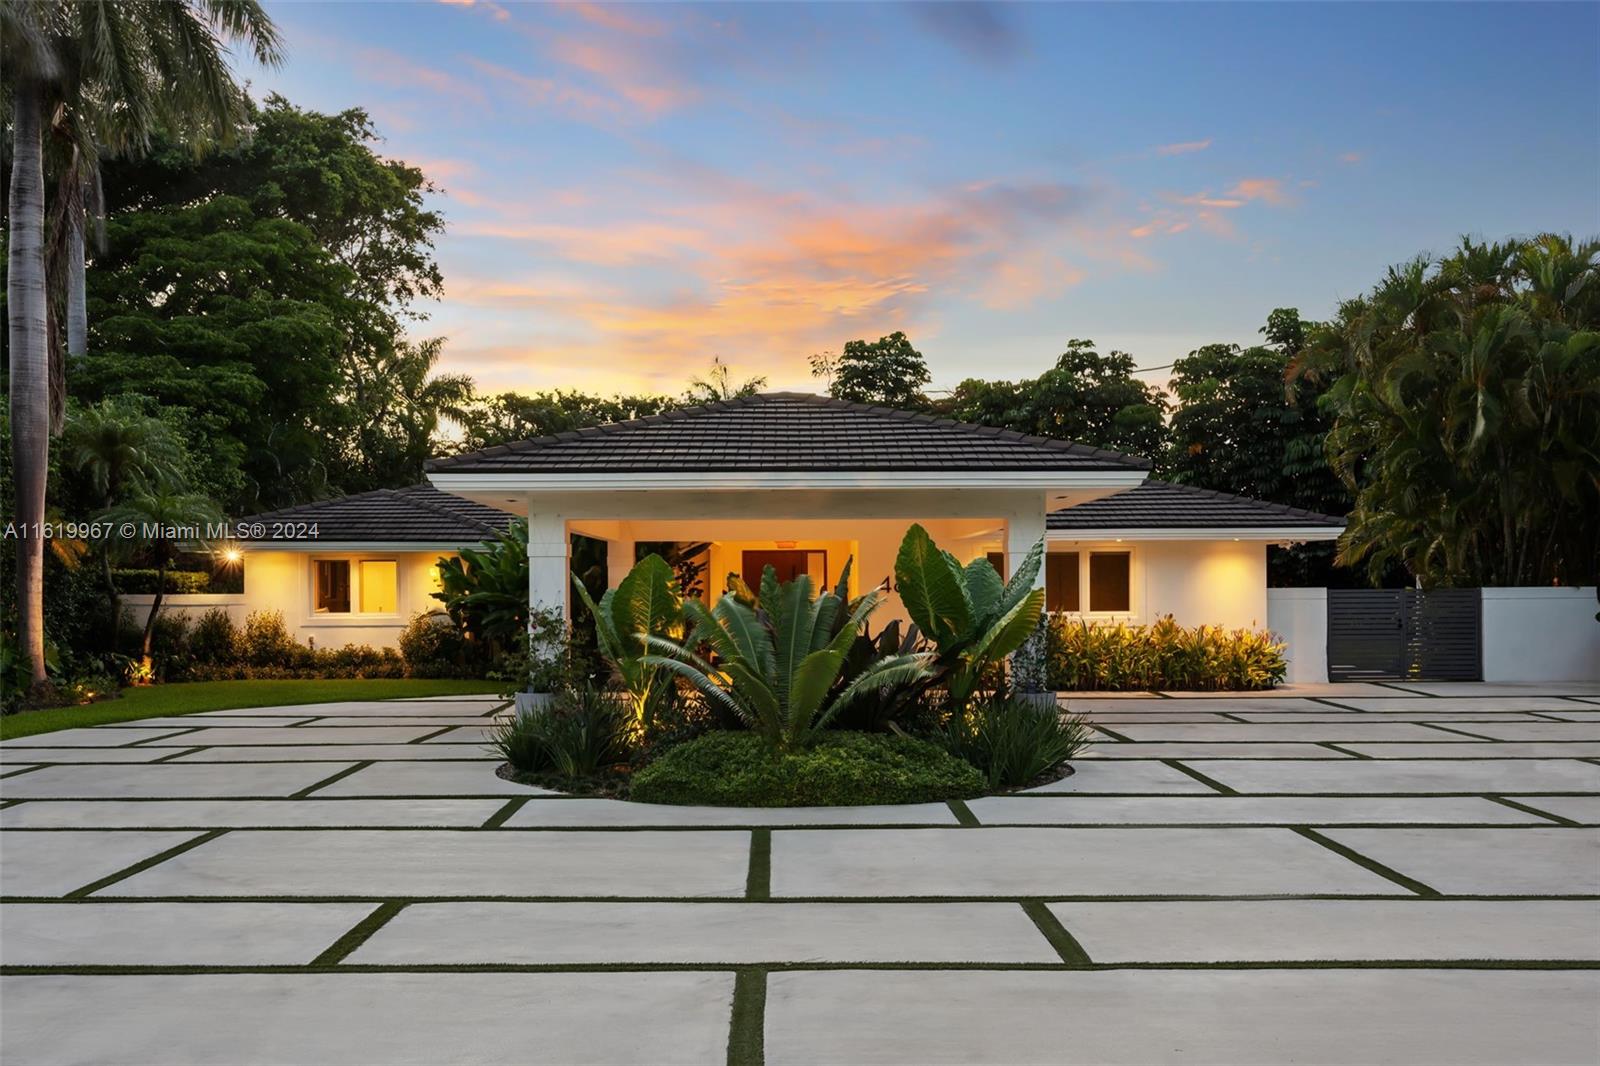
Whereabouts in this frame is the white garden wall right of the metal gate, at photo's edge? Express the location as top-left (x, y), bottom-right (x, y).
top-left (1483, 587), bottom-right (1600, 682)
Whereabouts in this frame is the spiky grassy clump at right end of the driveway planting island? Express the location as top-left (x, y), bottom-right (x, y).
top-left (942, 698), bottom-right (1090, 789)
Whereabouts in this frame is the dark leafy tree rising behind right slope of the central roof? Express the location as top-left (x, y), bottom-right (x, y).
top-left (936, 339), bottom-right (1166, 456)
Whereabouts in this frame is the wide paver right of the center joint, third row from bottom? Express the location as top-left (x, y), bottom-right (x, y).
top-left (771, 829), bottom-right (1398, 896)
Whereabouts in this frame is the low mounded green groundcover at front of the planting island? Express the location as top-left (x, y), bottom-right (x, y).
top-left (632, 731), bottom-right (984, 807)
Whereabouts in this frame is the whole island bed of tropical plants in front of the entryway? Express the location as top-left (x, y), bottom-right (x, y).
top-left (496, 525), bottom-right (1088, 807)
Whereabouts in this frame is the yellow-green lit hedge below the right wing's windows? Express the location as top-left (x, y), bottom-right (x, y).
top-left (1045, 615), bottom-right (1288, 691)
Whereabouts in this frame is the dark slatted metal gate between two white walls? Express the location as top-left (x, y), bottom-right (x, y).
top-left (1328, 589), bottom-right (1483, 680)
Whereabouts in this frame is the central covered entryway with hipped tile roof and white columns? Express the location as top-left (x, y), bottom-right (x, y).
top-left (429, 392), bottom-right (1149, 618)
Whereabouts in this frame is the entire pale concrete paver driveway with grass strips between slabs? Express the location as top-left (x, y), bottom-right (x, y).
top-left (0, 683), bottom-right (1600, 1066)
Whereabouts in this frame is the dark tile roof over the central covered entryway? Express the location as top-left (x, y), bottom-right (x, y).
top-left (427, 392), bottom-right (1150, 474)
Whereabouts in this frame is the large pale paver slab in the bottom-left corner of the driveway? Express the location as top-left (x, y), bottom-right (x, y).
top-left (0, 973), bottom-right (733, 1066)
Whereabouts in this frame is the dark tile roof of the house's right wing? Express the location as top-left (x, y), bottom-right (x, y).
top-left (1046, 480), bottom-right (1344, 530)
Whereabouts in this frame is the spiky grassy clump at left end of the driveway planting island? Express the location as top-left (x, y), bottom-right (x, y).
top-left (491, 685), bottom-right (632, 781)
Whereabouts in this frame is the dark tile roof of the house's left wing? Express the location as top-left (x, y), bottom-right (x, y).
top-left (238, 485), bottom-right (517, 544)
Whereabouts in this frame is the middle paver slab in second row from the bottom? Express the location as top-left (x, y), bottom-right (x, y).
top-left (349, 903), bottom-right (1061, 965)
